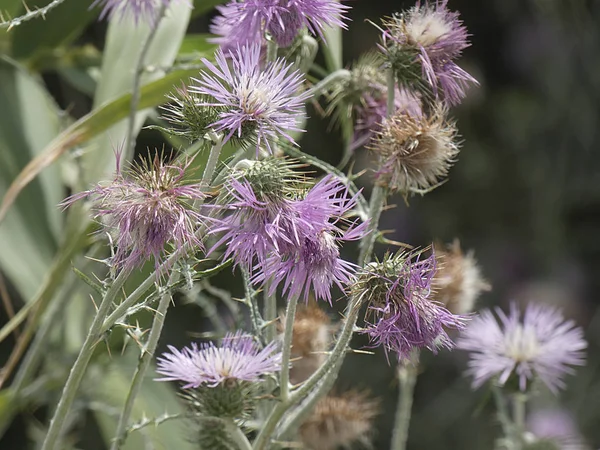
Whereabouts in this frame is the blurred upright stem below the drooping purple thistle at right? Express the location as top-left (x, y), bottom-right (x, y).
top-left (390, 351), bottom-right (419, 450)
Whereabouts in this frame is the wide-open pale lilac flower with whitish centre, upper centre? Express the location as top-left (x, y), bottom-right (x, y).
top-left (189, 45), bottom-right (310, 152)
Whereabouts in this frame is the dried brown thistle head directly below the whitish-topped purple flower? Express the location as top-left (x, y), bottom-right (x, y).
top-left (369, 108), bottom-right (459, 196)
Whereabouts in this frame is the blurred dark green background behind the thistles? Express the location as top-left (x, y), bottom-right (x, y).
top-left (0, 0), bottom-right (600, 450)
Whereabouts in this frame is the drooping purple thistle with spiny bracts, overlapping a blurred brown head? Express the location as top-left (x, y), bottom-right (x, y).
top-left (352, 253), bottom-right (465, 360)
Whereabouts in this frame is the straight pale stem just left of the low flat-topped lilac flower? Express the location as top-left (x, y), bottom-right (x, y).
top-left (110, 272), bottom-right (179, 450)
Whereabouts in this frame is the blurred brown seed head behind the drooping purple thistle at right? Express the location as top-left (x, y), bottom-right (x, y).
top-left (433, 240), bottom-right (491, 314)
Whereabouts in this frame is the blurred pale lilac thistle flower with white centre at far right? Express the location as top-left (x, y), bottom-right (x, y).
top-left (458, 303), bottom-right (587, 394)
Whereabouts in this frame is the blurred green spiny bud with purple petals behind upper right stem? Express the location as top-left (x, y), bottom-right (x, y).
top-left (325, 53), bottom-right (422, 150)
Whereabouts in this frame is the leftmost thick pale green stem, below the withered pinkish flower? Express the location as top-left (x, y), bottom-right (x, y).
top-left (42, 270), bottom-right (129, 450)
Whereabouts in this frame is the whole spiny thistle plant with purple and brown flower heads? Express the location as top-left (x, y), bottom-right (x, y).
top-left (0, 0), bottom-right (587, 450)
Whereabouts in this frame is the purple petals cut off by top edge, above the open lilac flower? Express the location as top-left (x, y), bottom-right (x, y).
top-left (211, 0), bottom-right (349, 49)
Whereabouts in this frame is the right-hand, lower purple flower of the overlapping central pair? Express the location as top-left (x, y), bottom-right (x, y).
top-left (255, 175), bottom-right (367, 302)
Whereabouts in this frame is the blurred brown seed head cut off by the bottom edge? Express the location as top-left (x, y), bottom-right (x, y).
top-left (300, 391), bottom-right (379, 450)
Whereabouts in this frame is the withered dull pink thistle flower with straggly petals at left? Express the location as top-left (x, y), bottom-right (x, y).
top-left (61, 154), bottom-right (206, 270)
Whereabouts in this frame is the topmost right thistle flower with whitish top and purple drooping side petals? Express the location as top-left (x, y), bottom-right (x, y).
top-left (380, 0), bottom-right (477, 105)
